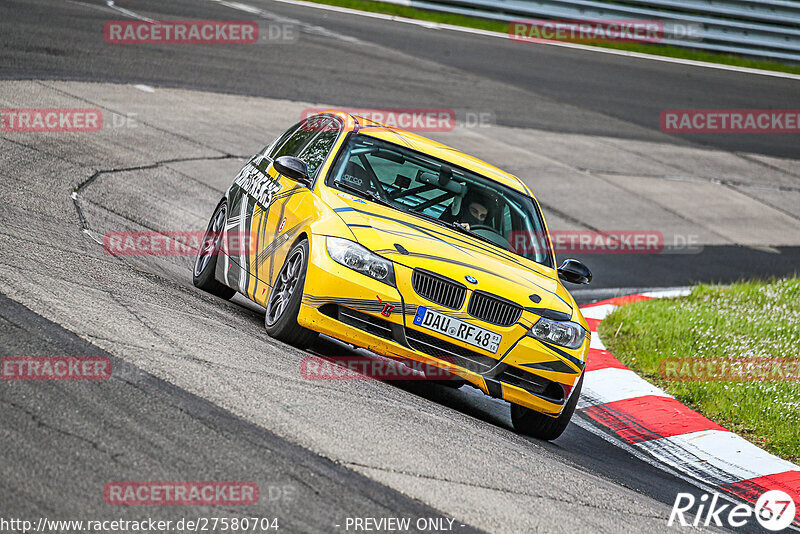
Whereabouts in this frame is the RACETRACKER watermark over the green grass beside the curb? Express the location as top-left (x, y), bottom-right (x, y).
top-left (660, 358), bottom-right (800, 382)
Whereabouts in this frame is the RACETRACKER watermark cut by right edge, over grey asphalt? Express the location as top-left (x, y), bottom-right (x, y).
top-left (660, 109), bottom-right (800, 133)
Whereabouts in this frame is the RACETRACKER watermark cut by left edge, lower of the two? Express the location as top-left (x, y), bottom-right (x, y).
top-left (0, 356), bottom-right (111, 380)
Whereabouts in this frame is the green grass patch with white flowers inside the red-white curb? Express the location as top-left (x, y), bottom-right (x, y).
top-left (600, 278), bottom-right (800, 462)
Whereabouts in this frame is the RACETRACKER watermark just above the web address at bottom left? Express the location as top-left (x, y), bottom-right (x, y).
top-left (103, 481), bottom-right (259, 506)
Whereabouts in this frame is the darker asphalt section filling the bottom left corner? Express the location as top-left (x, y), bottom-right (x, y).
top-left (0, 296), bottom-right (475, 532)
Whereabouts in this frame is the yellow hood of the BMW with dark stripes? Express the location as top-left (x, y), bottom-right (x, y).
top-left (328, 191), bottom-right (575, 316)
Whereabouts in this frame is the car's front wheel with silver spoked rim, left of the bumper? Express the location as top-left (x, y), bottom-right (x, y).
top-left (264, 239), bottom-right (317, 349)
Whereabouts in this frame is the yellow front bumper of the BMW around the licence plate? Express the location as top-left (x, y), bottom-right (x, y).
top-left (298, 236), bottom-right (589, 417)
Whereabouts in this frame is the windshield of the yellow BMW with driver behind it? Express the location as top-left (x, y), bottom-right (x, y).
top-left (328, 135), bottom-right (553, 267)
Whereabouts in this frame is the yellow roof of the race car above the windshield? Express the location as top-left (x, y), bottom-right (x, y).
top-left (318, 110), bottom-right (533, 196)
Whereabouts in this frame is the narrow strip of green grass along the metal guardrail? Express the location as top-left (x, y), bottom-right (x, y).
top-left (296, 0), bottom-right (800, 74)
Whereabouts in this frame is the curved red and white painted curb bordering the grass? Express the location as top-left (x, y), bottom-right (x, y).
top-left (578, 290), bottom-right (800, 523)
